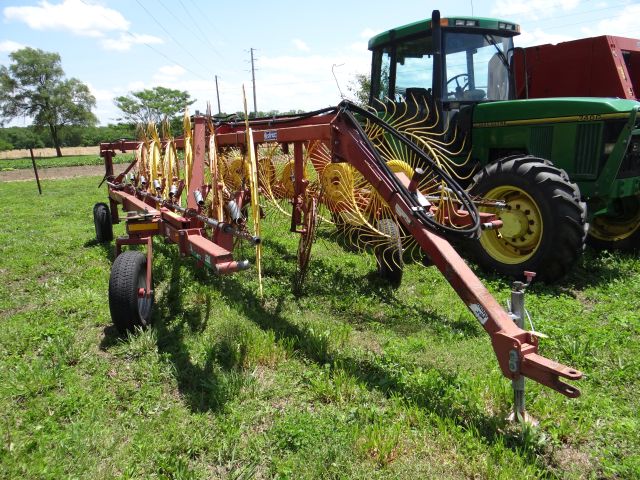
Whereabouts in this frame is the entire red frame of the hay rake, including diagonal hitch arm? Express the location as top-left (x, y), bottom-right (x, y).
top-left (100, 109), bottom-right (582, 398)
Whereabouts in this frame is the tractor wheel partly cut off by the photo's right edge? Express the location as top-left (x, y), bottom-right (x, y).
top-left (587, 195), bottom-right (640, 251)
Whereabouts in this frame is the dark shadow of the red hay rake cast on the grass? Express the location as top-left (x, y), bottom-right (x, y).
top-left (92, 231), bottom-right (592, 459)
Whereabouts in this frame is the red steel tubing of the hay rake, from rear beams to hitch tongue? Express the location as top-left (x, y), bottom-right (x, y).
top-left (101, 110), bottom-right (582, 398)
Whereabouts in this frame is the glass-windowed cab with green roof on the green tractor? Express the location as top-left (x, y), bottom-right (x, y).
top-left (369, 10), bottom-right (520, 129)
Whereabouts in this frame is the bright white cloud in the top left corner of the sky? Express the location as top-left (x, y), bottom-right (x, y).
top-left (3, 0), bottom-right (129, 37)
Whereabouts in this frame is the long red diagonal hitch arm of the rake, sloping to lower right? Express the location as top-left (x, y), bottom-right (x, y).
top-left (332, 108), bottom-right (582, 398)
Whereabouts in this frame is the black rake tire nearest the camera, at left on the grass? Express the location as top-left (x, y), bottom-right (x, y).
top-left (109, 250), bottom-right (153, 333)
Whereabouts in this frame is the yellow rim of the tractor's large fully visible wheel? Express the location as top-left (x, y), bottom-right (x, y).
top-left (480, 185), bottom-right (543, 265)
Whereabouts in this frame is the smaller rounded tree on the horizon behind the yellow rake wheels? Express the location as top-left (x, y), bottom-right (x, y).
top-left (114, 87), bottom-right (195, 124)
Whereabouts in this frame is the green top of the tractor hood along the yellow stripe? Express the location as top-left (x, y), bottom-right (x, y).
top-left (473, 97), bottom-right (640, 127)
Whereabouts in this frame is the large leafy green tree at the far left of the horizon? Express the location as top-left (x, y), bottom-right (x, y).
top-left (0, 47), bottom-right (97, 157)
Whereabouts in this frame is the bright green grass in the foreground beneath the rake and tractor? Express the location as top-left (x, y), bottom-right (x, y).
top-left (0, 178), bottom-right (640, 479)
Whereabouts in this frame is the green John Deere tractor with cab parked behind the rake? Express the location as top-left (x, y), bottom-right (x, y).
top-left (369, 10), bottom-right (640, 282)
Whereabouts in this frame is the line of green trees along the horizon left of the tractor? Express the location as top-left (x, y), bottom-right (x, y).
top-left (0, 47), bottom-right (318, 157)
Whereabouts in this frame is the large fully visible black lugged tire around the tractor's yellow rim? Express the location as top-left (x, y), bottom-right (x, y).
top-left (470, 156), bottom-right (588, 283)
